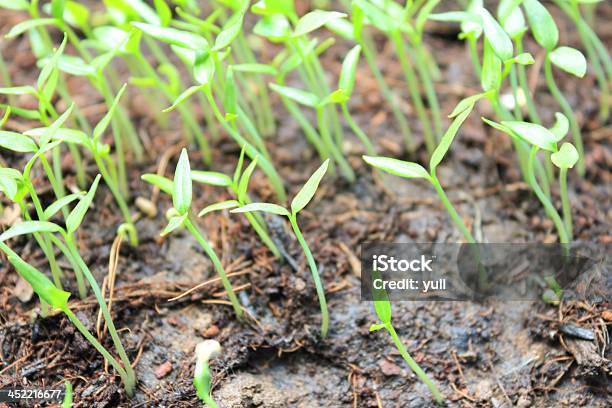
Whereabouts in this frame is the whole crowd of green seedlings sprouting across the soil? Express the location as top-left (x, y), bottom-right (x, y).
top-left (0, 0), bottom-right (612, 407)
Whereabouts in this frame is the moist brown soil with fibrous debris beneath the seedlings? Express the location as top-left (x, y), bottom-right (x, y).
top-left (0, 2), bottom-right (612, 408)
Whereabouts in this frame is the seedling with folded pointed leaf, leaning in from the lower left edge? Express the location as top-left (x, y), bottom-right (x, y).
top-left (0, 242), bottom-right (136, 396)
